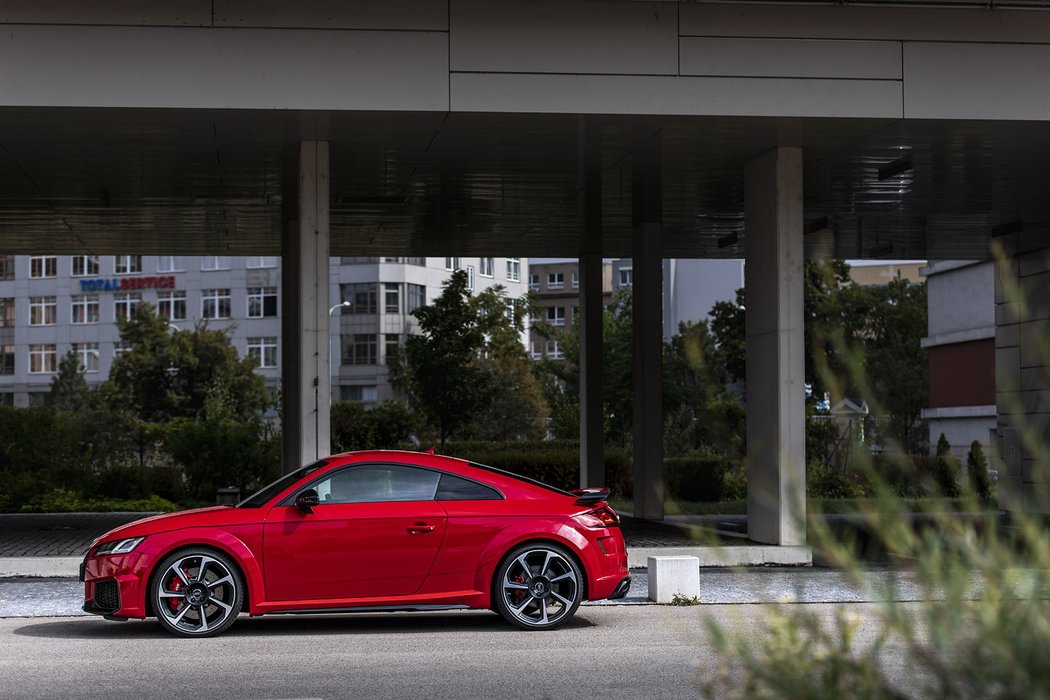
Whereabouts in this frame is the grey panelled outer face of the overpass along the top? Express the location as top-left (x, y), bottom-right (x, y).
top-left (6, 0), bottom-right (1050, 120)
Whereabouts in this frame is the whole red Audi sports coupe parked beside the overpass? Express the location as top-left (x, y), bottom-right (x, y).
top-left (81, 451), bottom-right (631, 637)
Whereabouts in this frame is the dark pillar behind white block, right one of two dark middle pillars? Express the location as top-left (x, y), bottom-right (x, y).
top-left (631, 131), bottom-right (664, 519)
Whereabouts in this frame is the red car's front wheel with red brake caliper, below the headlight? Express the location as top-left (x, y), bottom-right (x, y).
top-left (150, 549), bottom-right (245, 637)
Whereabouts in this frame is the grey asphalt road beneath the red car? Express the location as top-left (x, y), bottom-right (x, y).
top-left (0, 603), bottom-right (919, 700)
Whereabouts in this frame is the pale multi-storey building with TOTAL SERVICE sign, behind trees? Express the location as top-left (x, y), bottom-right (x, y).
top-left (0, 255), bottom-right (528, 406)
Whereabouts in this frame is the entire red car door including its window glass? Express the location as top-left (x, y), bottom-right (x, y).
top-left (263, 464), bottom-right (446, 600)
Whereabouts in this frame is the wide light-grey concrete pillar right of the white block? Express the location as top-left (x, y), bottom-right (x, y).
top-left (744, 148), bottom-right (805, 545)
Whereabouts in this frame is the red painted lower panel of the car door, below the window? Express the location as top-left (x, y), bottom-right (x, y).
top-left (263, 501), bottom-right (446, 600)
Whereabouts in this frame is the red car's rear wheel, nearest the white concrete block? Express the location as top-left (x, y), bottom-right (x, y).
top-left (495, 543), bottom-right (584, 630)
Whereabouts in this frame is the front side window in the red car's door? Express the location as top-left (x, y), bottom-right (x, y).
top-left (314, 464), bottom-right (440, 504)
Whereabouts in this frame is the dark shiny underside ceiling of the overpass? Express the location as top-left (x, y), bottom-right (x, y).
top-left (0, 108), bottom-right (1050, 258)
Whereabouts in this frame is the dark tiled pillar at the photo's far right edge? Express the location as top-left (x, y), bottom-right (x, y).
top-left (992, 230), bottom-right (1050, 514)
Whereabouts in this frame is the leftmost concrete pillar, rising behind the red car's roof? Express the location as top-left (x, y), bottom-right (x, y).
top-left (281, 141), bottom-right (332, 472)
